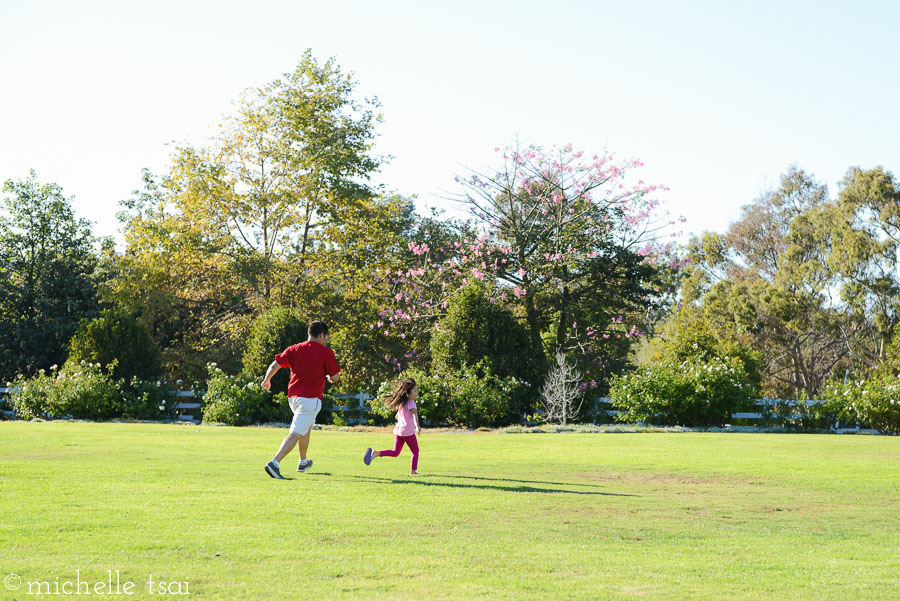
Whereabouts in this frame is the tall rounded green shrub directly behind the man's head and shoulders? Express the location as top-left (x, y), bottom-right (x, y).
top-left (243, 307), bottom-right (307, 392)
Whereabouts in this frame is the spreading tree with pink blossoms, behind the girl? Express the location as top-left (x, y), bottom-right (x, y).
top-left (372, 145), bottom-right (678, 386)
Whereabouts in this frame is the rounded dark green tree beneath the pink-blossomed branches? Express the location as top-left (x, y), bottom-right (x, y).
top-left (431, 283), bottom-right (540, 384)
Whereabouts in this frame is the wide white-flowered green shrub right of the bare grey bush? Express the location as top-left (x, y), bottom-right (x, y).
top-left (610, 357), bottom-right (755, 427)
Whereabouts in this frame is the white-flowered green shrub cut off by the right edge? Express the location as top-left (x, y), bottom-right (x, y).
top-left (825, 372), bottom-right (900, 434)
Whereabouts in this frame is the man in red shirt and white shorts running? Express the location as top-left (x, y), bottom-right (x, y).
top-left (262, 321), bottom-right (341, 479)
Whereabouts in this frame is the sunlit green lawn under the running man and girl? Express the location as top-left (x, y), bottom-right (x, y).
top-left (0, 422), bottom-right (900, 601)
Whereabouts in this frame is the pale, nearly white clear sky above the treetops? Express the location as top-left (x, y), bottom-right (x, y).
top-left (0, 0), bottom-right (900, 243)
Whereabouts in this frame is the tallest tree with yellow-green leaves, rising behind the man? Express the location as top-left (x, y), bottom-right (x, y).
top-left (108, 52), bottom-right (384, 380)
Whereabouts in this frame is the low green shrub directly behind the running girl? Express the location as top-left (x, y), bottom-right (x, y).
top-left (371, 364), bottom-right (532, 428)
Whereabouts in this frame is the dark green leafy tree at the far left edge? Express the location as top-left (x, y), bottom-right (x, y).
top-left (0, 171), bottom-right (99, 379)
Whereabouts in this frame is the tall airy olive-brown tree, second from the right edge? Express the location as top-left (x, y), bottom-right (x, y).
top-left (683, 167), bottom-right (846, 398)
